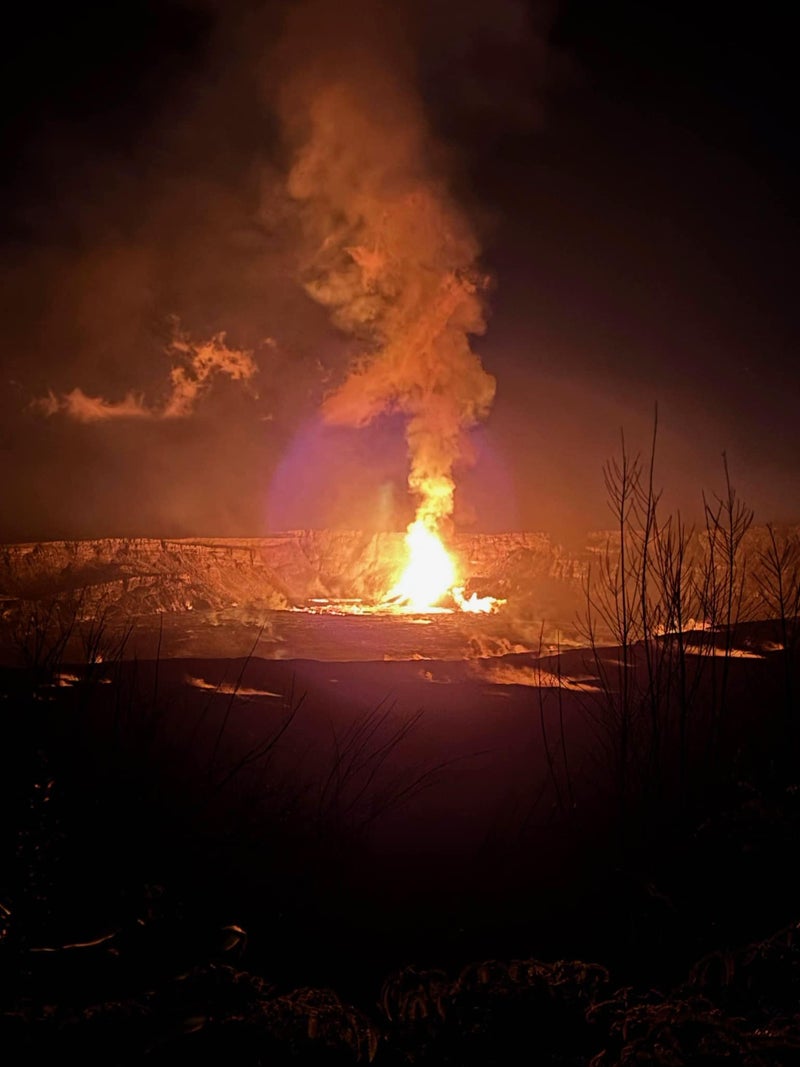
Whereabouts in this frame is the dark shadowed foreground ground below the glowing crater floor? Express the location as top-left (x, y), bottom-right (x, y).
top-left (0, 620), bottom-right (800, 1065)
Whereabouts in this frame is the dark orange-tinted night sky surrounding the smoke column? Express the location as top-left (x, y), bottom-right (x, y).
top-left (0, 0), bottom-right (800, 541)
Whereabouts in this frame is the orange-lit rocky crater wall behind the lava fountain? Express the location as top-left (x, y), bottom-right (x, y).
top-left (0, 530), bottom-right (586, 616)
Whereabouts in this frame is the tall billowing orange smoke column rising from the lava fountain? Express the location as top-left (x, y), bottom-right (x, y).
top-left (281, 2), bottom-right (495, 528)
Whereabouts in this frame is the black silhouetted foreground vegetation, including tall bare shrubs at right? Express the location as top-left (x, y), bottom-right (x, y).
top-left (0, 433), bottom-right (800, 1054)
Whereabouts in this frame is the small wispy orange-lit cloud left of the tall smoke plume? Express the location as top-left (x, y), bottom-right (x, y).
top-left (31, 325), bottom-right (258, 423)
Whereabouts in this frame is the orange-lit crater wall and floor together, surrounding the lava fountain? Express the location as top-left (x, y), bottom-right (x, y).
top-left (0, 527), bottom-right (798, 664)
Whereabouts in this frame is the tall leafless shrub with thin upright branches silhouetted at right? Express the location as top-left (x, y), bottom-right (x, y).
top-left (580, 420), bottom-right (772, 834)
